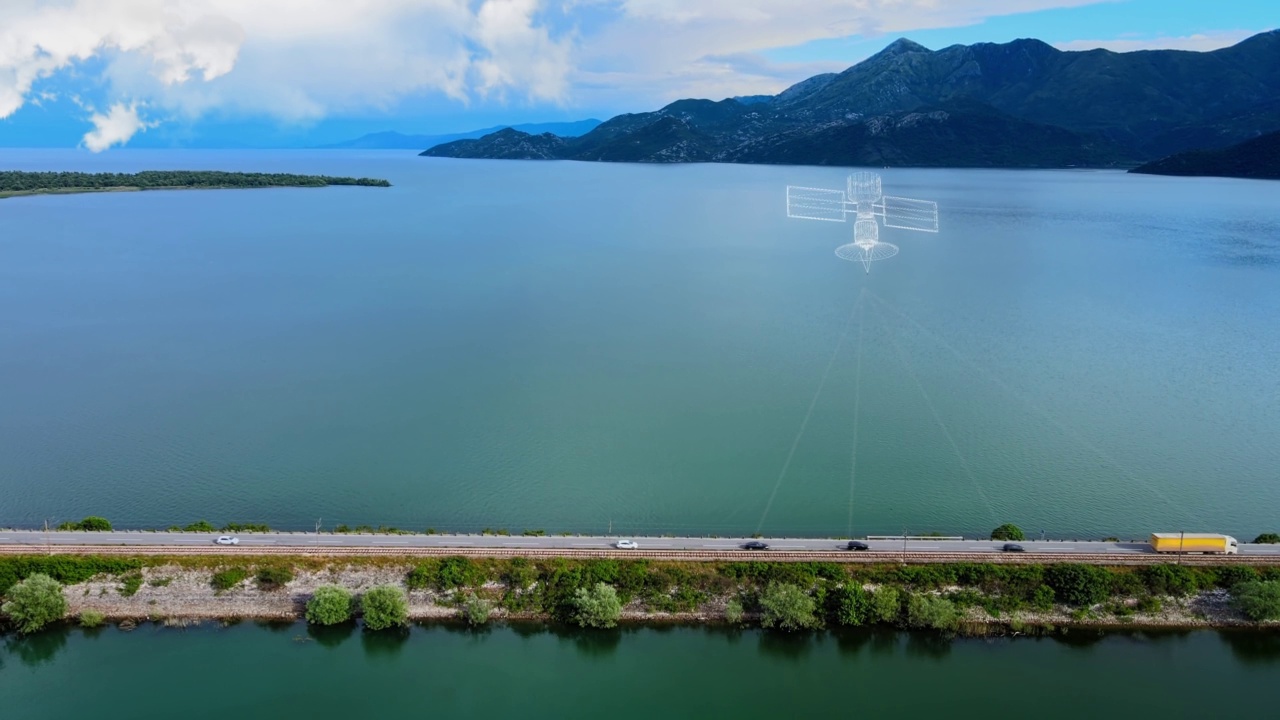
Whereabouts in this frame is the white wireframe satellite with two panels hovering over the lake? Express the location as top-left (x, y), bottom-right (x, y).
top-left (787, 172), bottom-right (938, 273)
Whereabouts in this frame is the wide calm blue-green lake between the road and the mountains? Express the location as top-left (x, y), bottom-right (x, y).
top-left (0, 150), bottom-right (1280, 532)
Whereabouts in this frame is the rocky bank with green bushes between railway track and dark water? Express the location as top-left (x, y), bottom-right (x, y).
top-left (0, 556), bottom-right (1280, 634)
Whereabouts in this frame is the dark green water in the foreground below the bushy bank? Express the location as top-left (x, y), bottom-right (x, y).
top-left (0, 625), bottom-right (1280, 720)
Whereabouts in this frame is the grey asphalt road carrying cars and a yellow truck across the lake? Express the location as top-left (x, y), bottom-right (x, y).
top-left (0, 530), bottom-right (1280, 556)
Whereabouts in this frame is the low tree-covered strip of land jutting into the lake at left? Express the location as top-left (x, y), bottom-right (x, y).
top-left (0, 170), bottom-right (392, 197)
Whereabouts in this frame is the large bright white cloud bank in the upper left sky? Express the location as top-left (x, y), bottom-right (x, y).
top-left (0, 0), bottom-right (571, 119)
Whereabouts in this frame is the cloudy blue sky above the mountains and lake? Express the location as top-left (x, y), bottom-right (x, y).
top-left (0, 0), bottom-right (1280, 152)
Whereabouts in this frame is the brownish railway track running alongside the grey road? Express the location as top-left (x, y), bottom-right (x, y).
top-left (0, 544), bottom-right (1280, 565)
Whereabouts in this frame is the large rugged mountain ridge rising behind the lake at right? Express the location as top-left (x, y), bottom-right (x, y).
top-left (422, 31), bottom-right (1280, 167)
